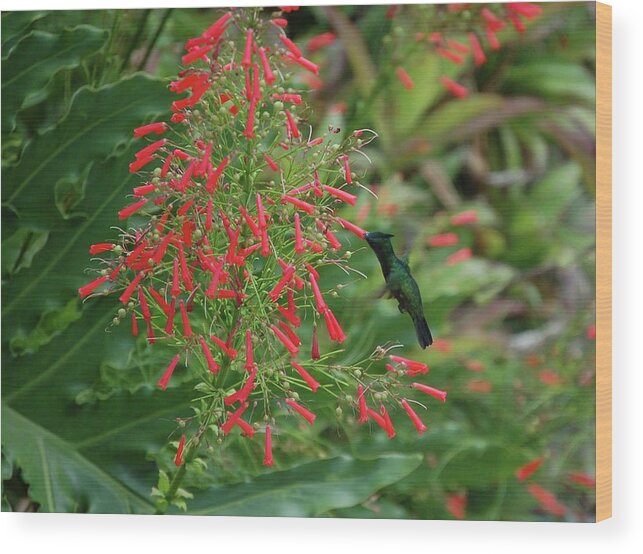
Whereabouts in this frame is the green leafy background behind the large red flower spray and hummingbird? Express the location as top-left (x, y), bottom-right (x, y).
top-left (2, 2), bottom-right (595, 521)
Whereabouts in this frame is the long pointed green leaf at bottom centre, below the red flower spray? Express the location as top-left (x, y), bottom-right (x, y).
top-left (189, 454), bottom-right (422, 517)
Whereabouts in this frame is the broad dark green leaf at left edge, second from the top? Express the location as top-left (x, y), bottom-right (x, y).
top-left (3, 75), bottom-right (171, 230)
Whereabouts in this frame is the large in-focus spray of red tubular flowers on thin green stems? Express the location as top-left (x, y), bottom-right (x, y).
top-left (79, 9), bottom-right (446, 474)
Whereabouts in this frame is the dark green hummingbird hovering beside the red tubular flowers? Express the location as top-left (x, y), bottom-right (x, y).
top-left (364, 231), bottom-right (433, 348)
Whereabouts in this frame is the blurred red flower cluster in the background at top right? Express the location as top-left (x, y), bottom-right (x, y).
top-left (391, 2), bottom-right (542, 98)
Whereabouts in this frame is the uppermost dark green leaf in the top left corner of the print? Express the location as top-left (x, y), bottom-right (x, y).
top-left (2, 25), bottom-right (108, 134)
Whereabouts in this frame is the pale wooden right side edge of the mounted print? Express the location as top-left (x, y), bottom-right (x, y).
top-left (596, 2), bottom-right (612, 522)
